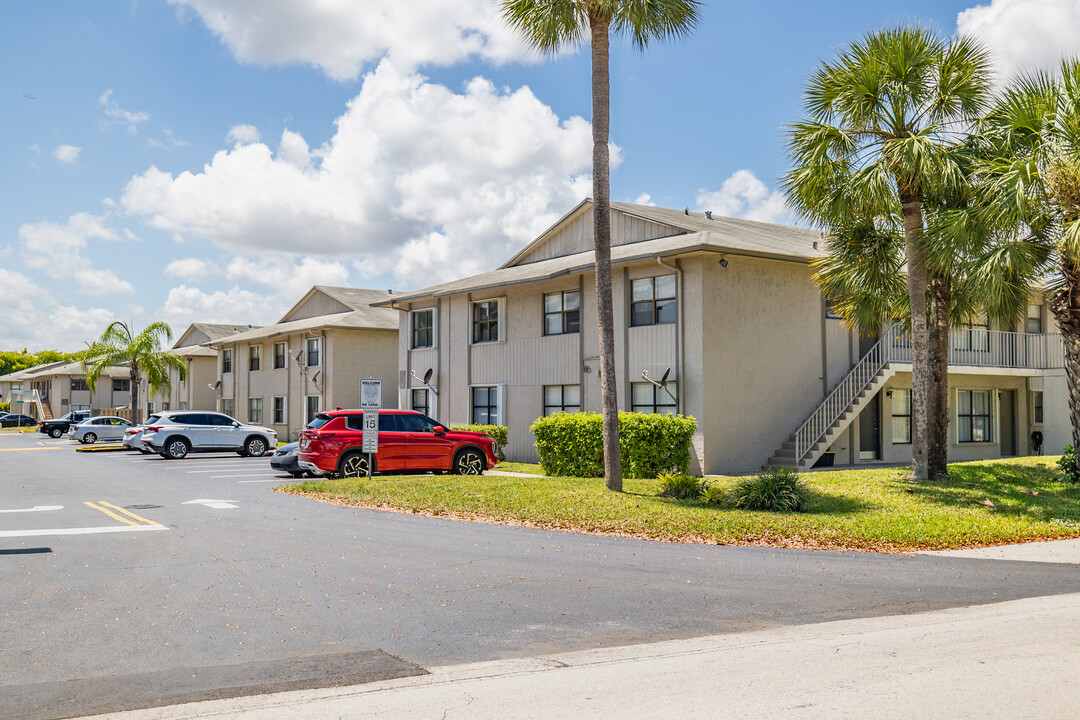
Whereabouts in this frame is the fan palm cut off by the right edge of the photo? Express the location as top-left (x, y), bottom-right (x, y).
top-left (978, 59), bottom-right (1080, 464)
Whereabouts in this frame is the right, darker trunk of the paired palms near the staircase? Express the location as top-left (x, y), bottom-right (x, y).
top-left (927, 274), bottom-right (953, 480)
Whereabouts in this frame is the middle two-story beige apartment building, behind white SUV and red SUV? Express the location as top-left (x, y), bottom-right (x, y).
top-left (203, 285), bottom-right (399, 439)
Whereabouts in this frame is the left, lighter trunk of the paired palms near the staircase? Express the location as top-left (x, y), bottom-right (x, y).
top-left (900, 193), bottom-right (932, 480)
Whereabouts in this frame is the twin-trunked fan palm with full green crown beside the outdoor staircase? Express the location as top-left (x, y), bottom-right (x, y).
top-left (784, 27), bottom-right (989, 479)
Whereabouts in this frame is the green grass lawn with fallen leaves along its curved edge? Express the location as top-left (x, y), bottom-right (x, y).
top-left (280, 457), bottom-right (1080, 553)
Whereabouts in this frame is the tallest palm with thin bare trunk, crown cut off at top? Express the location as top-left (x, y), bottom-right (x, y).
top-left (502, 0), bottom-right (700, 492)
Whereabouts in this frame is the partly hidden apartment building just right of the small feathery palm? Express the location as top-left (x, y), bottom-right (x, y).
top-left (144, 323), bottom-right (251, 417)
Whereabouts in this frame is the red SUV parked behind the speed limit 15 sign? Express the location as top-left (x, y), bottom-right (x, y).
top-left (299, 410), bottom-right (499, 477)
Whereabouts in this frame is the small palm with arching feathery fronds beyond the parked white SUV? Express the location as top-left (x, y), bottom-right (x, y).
top-left (82, 321), bottom-right (188, 423)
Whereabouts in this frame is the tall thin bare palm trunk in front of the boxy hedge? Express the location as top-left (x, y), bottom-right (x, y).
top-left (589, 14), bottom-right (622, 492)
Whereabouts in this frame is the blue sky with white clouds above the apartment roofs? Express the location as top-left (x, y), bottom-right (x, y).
top-left (0, 0), bottom-right (1080, 350)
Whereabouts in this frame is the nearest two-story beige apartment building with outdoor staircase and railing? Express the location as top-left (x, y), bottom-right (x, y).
top-left (382, 200), bottom-right (1068, 474)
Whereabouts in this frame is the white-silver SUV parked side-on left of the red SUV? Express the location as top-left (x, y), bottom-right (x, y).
top-left (139, 410), bottom-right (278, 460)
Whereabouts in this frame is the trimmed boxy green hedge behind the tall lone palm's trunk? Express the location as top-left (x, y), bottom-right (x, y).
top-left (530, 412), bottom-right (698, 477)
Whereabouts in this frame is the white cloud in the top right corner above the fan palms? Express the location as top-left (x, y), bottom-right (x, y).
top-left (956, 0), bottom-right (1080, 78)
